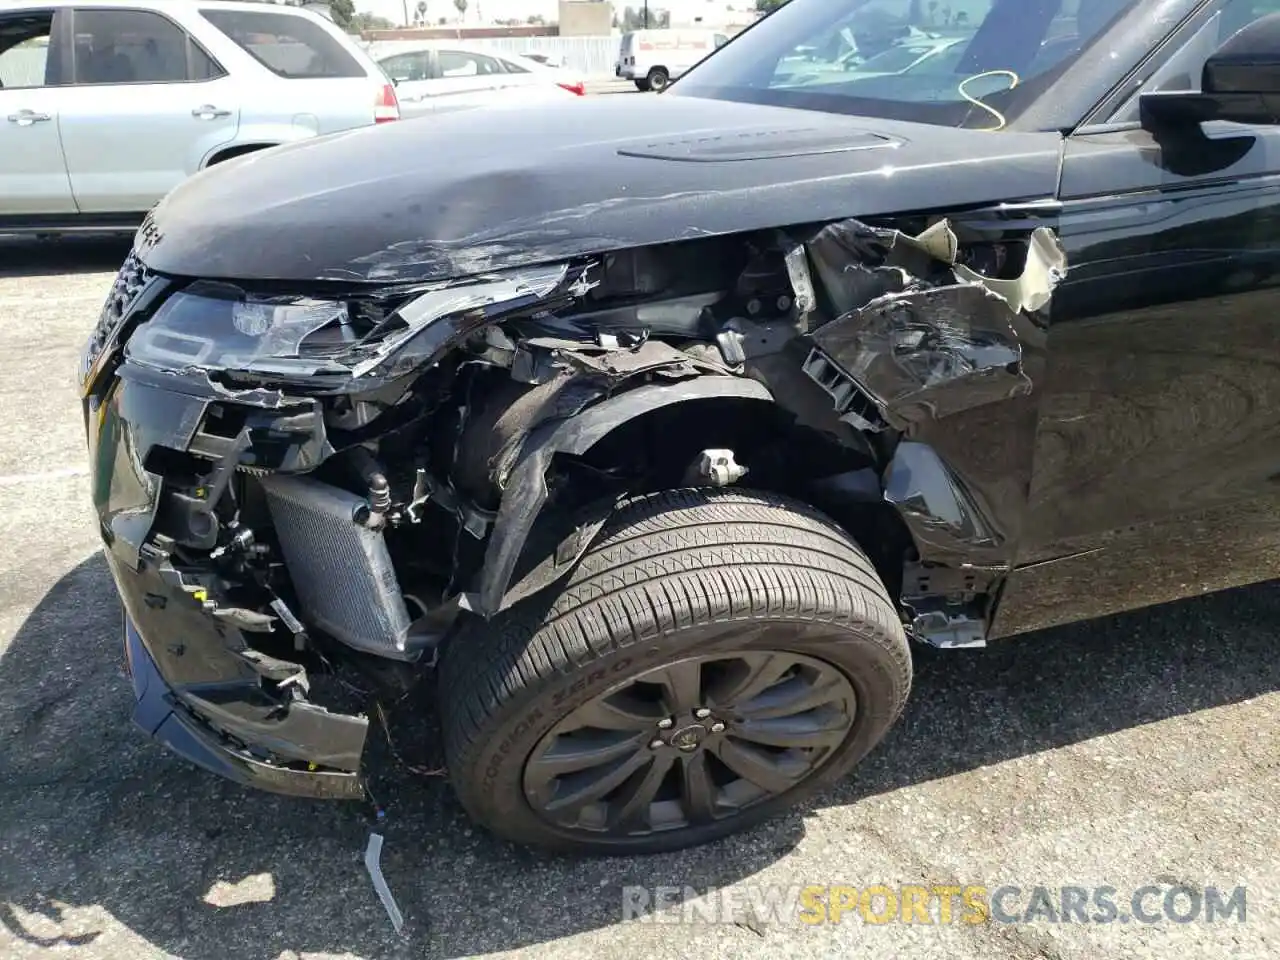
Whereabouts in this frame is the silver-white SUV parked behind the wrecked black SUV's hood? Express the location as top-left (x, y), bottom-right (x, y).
top-left (0, 0), bottom-right (399, 233)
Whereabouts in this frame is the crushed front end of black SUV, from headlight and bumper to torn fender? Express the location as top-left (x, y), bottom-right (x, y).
top-left (81, 213), bottom-right (1065, 797)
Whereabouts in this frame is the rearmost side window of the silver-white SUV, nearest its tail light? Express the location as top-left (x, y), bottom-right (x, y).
top-left (200, 6), bottom-right (366, 79)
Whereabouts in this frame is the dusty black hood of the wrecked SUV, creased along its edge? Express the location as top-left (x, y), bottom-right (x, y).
top-left (138, 95), bottom-right (1060, 283)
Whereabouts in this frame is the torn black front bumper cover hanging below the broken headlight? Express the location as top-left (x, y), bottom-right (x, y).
top-left (84, 363), bottom-right (369, 799)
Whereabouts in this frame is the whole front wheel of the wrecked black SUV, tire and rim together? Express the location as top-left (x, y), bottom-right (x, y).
top-left (439, 488), bottom-right (911, 854)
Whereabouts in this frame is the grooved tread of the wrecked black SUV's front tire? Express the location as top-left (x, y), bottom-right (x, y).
top-left (440, 488), bottom-right (911, 849)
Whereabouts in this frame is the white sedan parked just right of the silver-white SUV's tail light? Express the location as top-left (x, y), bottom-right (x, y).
top-left (374, 44), bottom-right (586, 119)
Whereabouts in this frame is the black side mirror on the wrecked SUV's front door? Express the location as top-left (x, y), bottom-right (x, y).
top-left (1139, 13), bottom-right (1280, 131)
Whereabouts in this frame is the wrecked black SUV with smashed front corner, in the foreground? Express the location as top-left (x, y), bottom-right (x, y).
top-left (81, 0), bottom-right (1280, 852)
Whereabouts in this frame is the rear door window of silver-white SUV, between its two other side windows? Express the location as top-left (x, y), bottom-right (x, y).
top-left (73, 9), bottom-right (187, 86)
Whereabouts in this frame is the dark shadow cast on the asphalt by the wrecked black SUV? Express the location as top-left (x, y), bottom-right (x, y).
top-left (0, 556), bottom-right (1280, 960)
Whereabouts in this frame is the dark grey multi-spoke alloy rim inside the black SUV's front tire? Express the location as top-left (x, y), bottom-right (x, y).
top-left (524, 650), bottom-right (858, 836)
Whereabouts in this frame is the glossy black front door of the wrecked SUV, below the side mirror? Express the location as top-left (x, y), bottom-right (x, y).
top-left (992, 0), bottom-right (1280, 635)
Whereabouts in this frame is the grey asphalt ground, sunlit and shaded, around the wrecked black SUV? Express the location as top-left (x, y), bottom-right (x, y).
top-left (0, 227), bottom-right (1280, 960)
